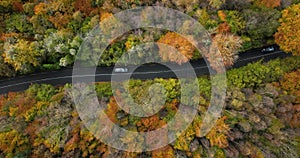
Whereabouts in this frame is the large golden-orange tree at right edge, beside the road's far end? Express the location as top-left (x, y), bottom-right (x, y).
top-left (275, 3), bottom-right (300, 55)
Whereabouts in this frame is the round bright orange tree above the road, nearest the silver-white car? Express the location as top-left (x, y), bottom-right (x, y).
top-left (158, 32), bottom-right (195, 64)
